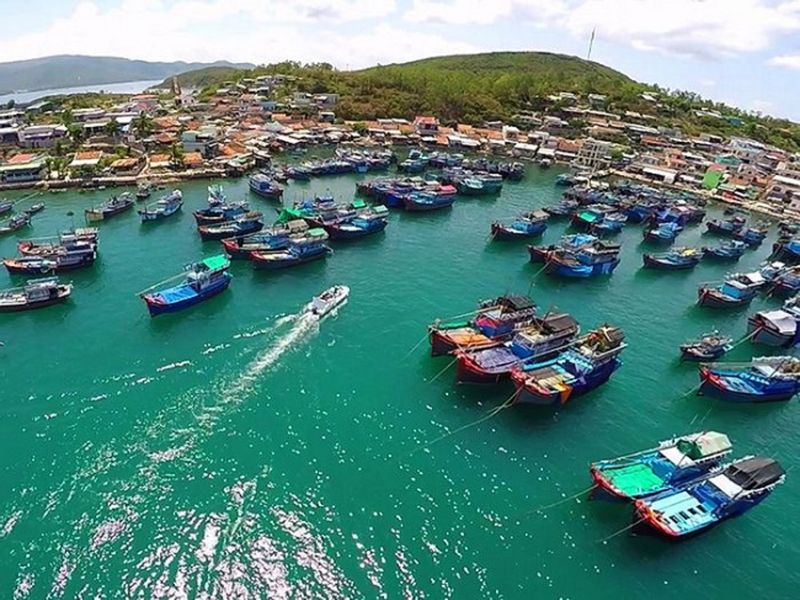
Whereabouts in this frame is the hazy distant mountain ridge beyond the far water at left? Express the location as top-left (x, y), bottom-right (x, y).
top-left (0, 55), bottom-right (253, 93)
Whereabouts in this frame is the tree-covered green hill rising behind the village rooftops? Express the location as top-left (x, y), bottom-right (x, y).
top-left (173, 52), bottom-right (643, 122)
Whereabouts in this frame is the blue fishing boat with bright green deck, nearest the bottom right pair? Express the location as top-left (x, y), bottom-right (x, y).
top-left (589, 431), bottom-right (733, 502)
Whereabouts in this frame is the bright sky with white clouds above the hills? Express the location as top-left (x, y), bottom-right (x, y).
top-left (0, 0), bottom-right (800, 121)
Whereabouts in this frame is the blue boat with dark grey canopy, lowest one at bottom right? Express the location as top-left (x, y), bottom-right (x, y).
top-left (634, 456), bottom-right (785, 540)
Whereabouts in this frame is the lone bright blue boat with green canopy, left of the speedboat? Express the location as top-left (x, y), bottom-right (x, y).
top-left (140, 254), bottom-right (232, 317)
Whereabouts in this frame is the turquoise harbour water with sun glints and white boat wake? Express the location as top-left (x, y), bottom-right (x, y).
top-left (0, 169), bottom-right (800, 598)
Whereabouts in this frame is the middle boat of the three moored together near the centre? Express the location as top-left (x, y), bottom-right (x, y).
top-left (454, 313), bottom-right (580, 383)
